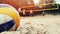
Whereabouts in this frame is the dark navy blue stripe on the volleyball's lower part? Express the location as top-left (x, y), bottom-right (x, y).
top-left (0, 20), bottom-right (15, 32)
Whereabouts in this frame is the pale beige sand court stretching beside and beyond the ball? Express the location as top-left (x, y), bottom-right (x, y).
top-left (1, 15), bottom-right (60, 34)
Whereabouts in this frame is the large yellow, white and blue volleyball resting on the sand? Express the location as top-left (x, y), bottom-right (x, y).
top-left (0, 4), bottom-right (20, 32)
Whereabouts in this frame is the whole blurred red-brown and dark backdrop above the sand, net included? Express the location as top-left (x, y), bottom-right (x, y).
top-left (0, 0), bottom-right (60, 16)
